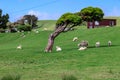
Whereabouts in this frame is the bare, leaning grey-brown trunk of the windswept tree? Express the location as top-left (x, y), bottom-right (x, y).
top-left (45, 24), bottom-right (67, 52)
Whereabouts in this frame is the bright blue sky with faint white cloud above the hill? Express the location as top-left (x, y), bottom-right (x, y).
top-left (0, 0), bottom-right (120, 21)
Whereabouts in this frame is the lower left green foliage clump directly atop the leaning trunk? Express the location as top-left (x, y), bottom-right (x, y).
top-left (56, 13), bottom-right (82, 26)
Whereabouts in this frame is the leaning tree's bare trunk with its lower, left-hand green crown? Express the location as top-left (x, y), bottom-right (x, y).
top-left (45, 13), bottom-right (82, 52)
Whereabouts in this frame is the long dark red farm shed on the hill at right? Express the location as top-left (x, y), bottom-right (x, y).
top-left (87, 19), bottom-right (116, 28)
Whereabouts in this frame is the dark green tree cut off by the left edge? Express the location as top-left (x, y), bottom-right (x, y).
top-left (0, 9), bottom-right (9, 29)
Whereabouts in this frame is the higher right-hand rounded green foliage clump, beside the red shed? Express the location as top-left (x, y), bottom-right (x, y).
top-left (80, 7), bottom-right (104, 21)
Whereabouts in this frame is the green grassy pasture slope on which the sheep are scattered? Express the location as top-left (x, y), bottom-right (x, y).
top-left (0, 24), bottom-right (120, 80)
